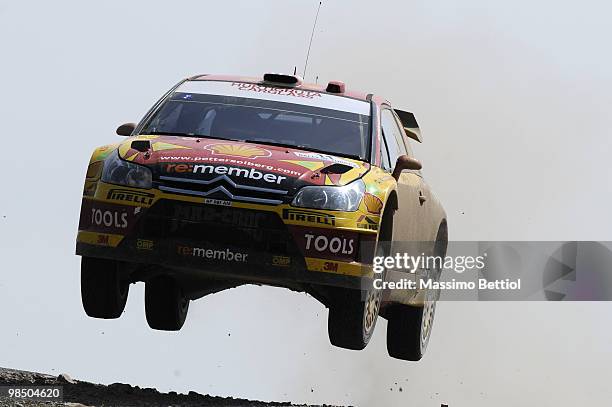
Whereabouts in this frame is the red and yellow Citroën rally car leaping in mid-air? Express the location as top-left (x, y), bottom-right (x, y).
top-left (76, 74), bottom-right (447, 360)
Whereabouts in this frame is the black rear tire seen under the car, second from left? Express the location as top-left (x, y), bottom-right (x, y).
top-left (145, 276), bottom-right (189, 331)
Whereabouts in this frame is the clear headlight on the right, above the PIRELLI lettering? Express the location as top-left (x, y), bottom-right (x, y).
top-left (291, 179), bottom-right (365, 212)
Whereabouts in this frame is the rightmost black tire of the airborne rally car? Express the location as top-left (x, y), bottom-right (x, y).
top-left (387, 301), bottom-right (436, 361)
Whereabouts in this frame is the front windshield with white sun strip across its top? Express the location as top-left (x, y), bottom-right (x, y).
top-left (140, 81), bottom-right (370, 160)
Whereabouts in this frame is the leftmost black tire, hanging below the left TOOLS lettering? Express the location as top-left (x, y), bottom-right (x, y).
top-left (81, 257), bottom-right (130, 319)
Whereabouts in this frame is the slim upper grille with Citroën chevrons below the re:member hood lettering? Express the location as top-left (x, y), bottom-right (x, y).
top-left (156, 175), bottom-right (287, 205)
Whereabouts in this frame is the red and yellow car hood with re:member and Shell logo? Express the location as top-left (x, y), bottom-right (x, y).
top-left (119, 135), bottom-right (369, 196)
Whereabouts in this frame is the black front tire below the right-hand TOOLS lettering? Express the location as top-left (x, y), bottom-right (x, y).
top-left (327, 289), bottom-right (381, 350)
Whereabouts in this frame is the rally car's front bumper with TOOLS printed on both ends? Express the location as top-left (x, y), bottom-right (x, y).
top-left (76, 197), bottom-right (376, 288)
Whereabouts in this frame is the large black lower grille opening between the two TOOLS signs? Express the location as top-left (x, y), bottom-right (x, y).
top-left (139, 200), bottom-right (298, 256)
